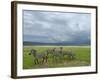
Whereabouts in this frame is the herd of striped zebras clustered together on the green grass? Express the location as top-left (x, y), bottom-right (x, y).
top-left (29, 47), bottom-right (75, 64)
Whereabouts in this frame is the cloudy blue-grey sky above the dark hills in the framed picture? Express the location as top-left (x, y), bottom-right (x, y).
top-left (23, 10), bottom-right (91, 43)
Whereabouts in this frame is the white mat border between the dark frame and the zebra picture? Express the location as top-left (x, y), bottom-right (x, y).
top-left (17, 4), bottom-right (96, 76)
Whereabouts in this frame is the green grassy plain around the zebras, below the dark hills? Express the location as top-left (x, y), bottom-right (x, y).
top-left (23, 46), bottom-right (91, 69)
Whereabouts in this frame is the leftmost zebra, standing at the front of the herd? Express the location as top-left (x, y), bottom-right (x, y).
top-left (29, 49), bottom-right (48, 64)
